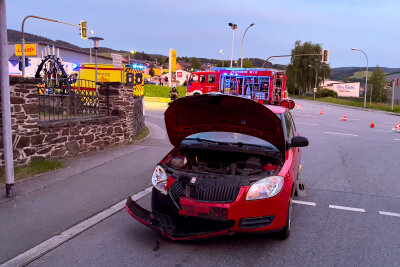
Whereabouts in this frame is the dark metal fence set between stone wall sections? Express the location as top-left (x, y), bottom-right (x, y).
top-left (37, 78), bottom-right (99, 121)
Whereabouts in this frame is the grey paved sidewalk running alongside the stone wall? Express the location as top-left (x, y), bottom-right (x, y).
top-left (0, 122), bottom-right (171, 264)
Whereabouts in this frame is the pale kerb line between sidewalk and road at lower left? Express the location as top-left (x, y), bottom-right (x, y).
top-left (0, 186), bottom-right (152, 267)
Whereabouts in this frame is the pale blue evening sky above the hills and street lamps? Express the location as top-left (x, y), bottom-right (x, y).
top-left (6, 0), bottom-right (400, 67)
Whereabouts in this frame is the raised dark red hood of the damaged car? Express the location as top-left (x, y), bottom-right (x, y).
top-left (164, 94), bottom-right (285, 153)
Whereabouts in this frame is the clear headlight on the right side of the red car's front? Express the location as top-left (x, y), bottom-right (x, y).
top-left (246, 176), bottom-right (283, 200)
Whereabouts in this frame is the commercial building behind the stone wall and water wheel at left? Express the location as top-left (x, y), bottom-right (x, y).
top-left (8, 42), bottom-right (112, 77)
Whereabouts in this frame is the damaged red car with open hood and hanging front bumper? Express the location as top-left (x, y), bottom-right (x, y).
top-left (126, 95), bottom-right (308, 240)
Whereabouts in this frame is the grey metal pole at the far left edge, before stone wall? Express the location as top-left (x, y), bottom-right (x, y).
top-left (0, 0), bottom-right (14, 197)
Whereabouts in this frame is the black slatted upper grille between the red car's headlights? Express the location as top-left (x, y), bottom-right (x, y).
top-left (189, 186), bottom-right (240, 202)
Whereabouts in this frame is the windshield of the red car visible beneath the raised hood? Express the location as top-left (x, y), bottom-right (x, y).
top-left (184, 132), bottom-right (276, 150)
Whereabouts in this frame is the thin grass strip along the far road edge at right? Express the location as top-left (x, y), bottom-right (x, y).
top-left (295, 96), bottom-right (400, 113)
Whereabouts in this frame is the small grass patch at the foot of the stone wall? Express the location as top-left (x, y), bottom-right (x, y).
top-left (0, 159), bottom-right (64, 183)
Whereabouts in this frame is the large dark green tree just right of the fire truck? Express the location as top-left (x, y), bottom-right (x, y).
top-left (287, 41), bottom-right (331, 94)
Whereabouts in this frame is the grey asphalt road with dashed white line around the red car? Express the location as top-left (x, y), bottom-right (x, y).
top-left (0, 101), bottom-right (400, 266)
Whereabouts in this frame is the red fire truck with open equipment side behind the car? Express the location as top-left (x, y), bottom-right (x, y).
top-left (187, 68), bottom-right (294, 108)
